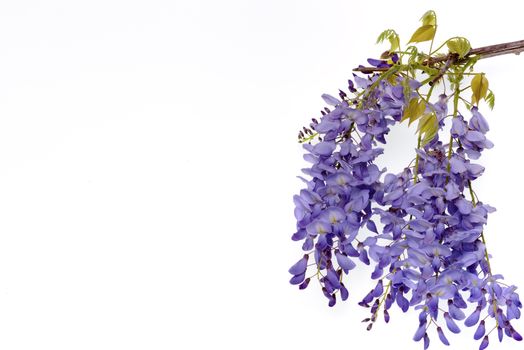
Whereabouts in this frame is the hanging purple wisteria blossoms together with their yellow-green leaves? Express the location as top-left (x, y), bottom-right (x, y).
top-left (289, 11), bottom-right (522, 350)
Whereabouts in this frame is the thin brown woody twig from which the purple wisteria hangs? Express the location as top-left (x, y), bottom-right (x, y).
top-left (353, 40), bottom-right (524, 73)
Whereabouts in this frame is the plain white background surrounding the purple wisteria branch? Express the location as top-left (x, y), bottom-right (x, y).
top-left (0, 0), bottom-right (524, 350)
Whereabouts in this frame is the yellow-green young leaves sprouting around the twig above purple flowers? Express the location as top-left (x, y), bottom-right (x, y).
top-left (377, 10), bottom-right (495, 146)
